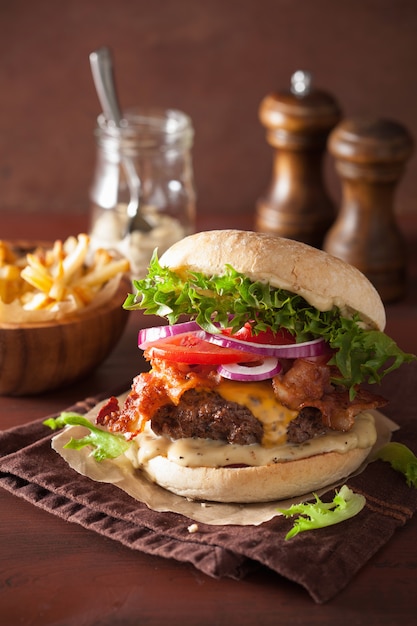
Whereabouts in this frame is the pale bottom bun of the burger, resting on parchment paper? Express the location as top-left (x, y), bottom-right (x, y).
top-left (142, 448), bottom-right (372, 503)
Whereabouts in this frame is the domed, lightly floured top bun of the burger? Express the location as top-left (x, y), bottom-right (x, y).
top-left (160, 230), bottom-right (386, 330)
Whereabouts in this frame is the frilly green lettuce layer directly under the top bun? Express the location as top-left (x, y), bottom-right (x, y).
top-left (123, 252), bottom-right (416, 397)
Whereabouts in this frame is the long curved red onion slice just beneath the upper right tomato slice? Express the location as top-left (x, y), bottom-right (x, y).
top-left (200, 332), bottom-right (326, 359)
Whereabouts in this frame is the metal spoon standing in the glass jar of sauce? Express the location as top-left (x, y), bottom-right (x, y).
top-left (90, 47), bottom-right (152, 235)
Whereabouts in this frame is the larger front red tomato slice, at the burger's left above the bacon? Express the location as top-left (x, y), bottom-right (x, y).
top-left (146, 333), bottom-right (260, 365)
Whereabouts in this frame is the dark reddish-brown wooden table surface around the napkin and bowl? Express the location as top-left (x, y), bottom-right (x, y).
top-left (0, 214), bottom-right (417, 626)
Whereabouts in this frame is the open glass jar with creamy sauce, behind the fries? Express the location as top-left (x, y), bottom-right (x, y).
top-left (90, 108), bottom-right (195, 278)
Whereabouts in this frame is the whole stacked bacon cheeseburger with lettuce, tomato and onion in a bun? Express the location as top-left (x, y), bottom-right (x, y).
top-left (96, 230), bottom-right (412, 503)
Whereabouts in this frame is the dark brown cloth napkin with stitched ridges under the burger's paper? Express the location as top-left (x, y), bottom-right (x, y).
top-left (0, 364), bottom-right (417, 603)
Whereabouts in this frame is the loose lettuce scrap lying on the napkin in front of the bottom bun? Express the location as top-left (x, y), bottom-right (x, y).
top-left (278, 485), bottom-right (366, 541)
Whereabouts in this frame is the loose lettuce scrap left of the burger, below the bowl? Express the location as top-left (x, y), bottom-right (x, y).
top-left (43, 412), bottom-right (130, 461)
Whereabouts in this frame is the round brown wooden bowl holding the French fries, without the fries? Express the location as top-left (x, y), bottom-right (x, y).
top-left (0, 278), bottom-right (131, 396)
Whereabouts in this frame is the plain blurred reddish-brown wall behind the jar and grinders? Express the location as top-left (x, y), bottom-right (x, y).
top-left (0, 0), bottom-right (417, 224)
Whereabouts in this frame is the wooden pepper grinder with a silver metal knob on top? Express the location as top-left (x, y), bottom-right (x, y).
top-left (255, 71), bottom-right (341, 247)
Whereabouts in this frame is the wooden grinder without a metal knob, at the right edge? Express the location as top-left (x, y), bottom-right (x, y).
top-left (324, 118), bottom-right (413, 302)
